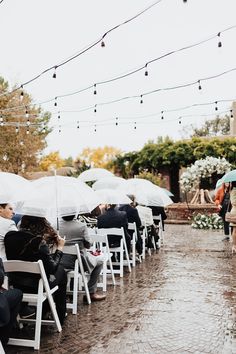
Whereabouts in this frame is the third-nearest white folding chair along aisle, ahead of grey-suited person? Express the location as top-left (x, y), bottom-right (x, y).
top-left (89, 230), bottom-right (116, 291)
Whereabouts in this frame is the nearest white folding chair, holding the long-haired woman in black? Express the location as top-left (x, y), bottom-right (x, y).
top-left (3, 260), bottom-right (62, 350)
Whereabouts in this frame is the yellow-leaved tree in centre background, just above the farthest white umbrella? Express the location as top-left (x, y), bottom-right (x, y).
top-left (78, 146), bottom-right (121, 168)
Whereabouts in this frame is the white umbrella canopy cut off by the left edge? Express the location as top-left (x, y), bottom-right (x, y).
top-left (0, 172), bottom-right (31, 203)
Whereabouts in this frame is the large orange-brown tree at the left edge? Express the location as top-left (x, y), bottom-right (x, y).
top-left (0, 77), bottom-right (51, 174)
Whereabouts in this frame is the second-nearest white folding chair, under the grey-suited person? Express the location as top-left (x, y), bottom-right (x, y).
top-left (63, 243), bottom-right (91, 315)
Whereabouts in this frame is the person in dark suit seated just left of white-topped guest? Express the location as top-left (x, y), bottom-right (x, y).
top-left (119, 195), bottom-right (142, 254)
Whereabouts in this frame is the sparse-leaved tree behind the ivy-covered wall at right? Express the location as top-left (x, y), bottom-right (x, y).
top-left (184, 115), bottom-right (230, 137)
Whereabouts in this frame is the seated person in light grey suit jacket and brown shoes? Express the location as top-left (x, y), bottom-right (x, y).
top-left (59, 215), bottom-right (106, 301)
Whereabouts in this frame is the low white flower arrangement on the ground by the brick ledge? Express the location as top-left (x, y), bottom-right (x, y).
top-left (191, 213), bottom-right (223, 230)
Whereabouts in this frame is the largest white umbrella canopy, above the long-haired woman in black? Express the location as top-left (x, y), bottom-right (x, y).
top-left (16, 176), bottom-right (99, 220)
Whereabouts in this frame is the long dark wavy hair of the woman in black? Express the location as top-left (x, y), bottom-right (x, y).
top-left (20, 215), bottom-right (58, 244)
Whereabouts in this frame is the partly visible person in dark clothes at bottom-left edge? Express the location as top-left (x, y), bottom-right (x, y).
top-left (0, 258), bottom-right (23, 346)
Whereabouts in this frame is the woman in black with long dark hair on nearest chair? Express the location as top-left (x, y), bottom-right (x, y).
top-left (5, 215), bottom-right (67, 325)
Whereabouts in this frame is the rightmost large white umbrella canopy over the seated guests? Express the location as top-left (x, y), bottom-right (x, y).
top-left (119, 178), bottom-right (173, 207)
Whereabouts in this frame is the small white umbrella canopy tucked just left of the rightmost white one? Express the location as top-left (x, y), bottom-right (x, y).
top-left (95, 188), bottom-right (132, 204)
